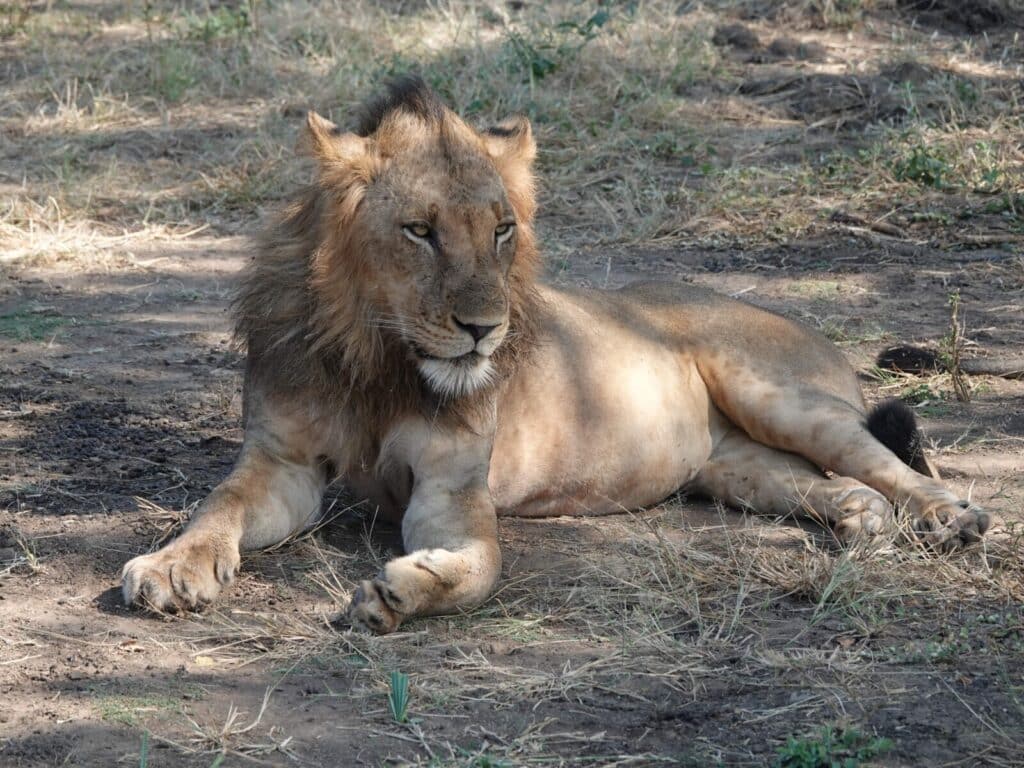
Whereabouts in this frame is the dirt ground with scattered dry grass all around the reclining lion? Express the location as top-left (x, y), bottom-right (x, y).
top-left (0, 2), bottom-right (1024, 768)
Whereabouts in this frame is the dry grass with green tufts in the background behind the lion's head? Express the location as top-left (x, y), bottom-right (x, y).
top-left (0, 0), bottom-right (1024, 260)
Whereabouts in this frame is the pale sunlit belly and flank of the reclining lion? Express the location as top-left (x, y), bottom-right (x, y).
top-left (488, 309), bottom-right (720, 517)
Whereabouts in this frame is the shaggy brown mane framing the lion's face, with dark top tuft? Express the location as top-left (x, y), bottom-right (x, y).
top-left (232, 77), bottom-right (540, 470)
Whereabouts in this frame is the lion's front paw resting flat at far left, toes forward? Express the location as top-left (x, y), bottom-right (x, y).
top-left (121, 534), bottom-right (241, 611)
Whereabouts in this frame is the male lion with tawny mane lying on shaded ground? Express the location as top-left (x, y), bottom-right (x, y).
top-left (123, 78), bottom-right (988, 633)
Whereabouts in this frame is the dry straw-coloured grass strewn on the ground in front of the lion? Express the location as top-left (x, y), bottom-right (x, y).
top-left (130, 505), bottom-right (1024, 765)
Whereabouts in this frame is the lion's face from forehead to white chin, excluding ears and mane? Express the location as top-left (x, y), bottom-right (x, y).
top-left (360, 142), bottom-right (516, 395)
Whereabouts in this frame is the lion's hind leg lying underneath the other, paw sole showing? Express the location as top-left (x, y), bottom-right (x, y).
top-left (692, 427), bottom-right (893, 544)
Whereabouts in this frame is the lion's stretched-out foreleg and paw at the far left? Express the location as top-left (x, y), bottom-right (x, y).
top-left (122, 444), bottom-right (325, 610)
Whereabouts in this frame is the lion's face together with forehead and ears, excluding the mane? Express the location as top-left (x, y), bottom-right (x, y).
top-left (310, 104), bottom-right (532, 397)
